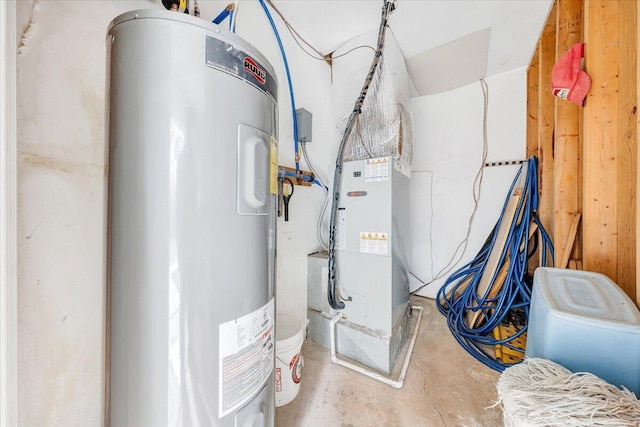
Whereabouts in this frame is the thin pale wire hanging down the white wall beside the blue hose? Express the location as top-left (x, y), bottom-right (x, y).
top-left (411, 79), bottom-right (489, 295)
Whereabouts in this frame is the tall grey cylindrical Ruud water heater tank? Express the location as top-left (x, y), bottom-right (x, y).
top-left (107, 10), bottom-right (277, 427)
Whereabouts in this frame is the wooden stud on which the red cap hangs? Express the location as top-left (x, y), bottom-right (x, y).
top-left (553, 0), bottom-right (582, 268)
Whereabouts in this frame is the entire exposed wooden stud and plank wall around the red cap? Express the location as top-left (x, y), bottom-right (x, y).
top-left (527, 0), bottom-right (640, 306)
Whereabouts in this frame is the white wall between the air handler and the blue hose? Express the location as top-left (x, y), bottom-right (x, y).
top-left (411, 67), bottom-right (527, 297)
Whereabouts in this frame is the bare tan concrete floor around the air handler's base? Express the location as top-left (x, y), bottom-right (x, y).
top-left (276, 298), bottom-right (502, 427)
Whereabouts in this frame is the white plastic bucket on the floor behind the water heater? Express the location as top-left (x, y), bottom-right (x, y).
top-left (275, 314), bottom-right (304, 406)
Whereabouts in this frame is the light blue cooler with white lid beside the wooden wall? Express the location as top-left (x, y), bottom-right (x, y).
top-left (526, 268), bottom-right (640, 397)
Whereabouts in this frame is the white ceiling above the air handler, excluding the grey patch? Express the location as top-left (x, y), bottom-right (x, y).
top-left (258, 0), bottom-right (552, 75)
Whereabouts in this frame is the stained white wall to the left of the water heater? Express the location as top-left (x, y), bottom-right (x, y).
top-left (18, 1), bottom-right (154, 426)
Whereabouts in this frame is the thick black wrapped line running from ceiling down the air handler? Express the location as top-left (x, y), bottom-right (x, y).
top-left (327, 0), bottom-right (395, 310)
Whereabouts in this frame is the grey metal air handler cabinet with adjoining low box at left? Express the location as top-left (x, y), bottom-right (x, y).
top-left (308, 157), bottom-right (410, 374)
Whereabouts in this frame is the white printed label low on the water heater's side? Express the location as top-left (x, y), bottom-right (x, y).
top-left (218, 299), bottom-right (275, 418)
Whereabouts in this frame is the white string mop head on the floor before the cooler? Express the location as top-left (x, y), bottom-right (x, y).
top-left (496, 359), bottom-right (640, 427)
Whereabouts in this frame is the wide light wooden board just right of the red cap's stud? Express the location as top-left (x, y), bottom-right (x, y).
top-left (583, 0), bottom-right (619, 281)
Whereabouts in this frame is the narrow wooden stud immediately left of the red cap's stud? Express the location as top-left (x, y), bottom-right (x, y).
top-left (537, 5), bottom-right (556, 244)
